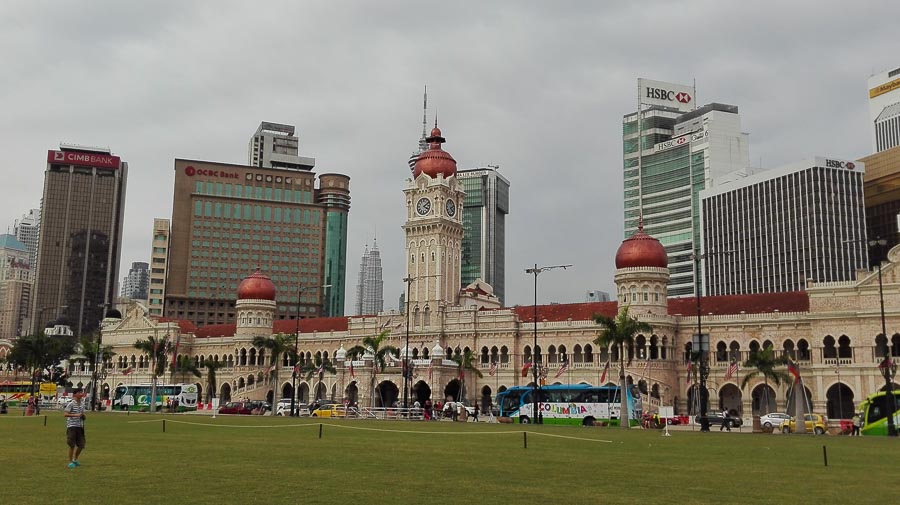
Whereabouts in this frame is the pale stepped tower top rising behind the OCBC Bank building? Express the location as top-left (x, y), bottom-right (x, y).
top-left (247, 121), bottom-right (316, 170)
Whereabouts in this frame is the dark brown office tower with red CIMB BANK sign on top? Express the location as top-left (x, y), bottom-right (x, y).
top-left (32, 144), bottom-right (128, 336)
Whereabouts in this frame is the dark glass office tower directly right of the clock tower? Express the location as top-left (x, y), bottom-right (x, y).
top-left (456, 166), bottom-right (509, 303)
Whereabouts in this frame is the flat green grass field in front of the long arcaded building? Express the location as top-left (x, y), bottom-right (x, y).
top-left (0, 411), bottom-right (900, 505)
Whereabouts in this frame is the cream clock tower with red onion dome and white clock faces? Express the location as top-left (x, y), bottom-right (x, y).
top-left (403, 122), bottom-right (465, 312)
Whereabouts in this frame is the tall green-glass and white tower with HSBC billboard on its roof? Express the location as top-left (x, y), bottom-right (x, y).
top-left (623, 79), bottom-right (750, 297)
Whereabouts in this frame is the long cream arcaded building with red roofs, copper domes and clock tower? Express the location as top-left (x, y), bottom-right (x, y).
top-left (72, 128), bottom-right (900, 419)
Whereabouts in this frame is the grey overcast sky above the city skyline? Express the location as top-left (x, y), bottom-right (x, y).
top-left (0, 0), bottom-right (900, 315)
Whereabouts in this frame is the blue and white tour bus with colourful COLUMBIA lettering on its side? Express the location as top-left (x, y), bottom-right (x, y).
top-left (497, 384), bottom-right (643, 426)
